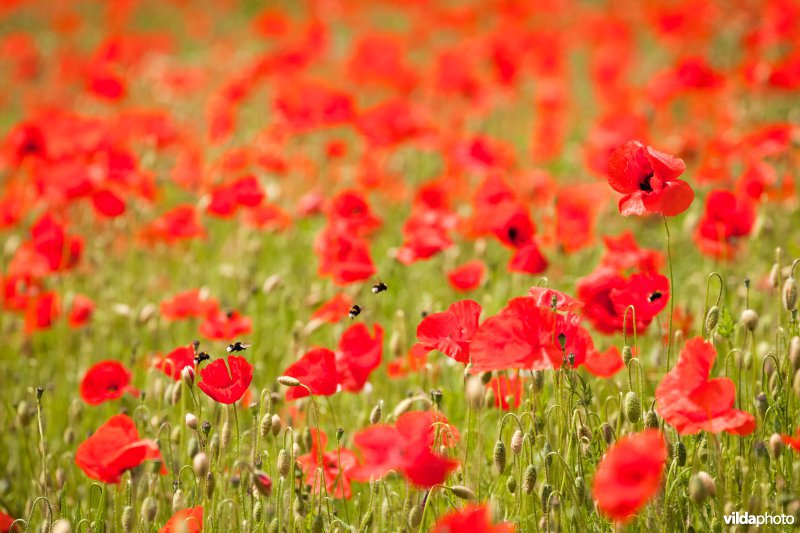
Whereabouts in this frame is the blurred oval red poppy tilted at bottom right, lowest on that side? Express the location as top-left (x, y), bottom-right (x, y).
top-left (593, 429), bottom-right (667, 523)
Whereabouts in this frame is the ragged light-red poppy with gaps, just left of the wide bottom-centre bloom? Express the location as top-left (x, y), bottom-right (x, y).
top-left (297, 429), bottom-right (358, 499)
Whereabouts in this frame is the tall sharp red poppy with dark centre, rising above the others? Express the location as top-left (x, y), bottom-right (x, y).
top-left (608, 141), bottom-right (694, 216)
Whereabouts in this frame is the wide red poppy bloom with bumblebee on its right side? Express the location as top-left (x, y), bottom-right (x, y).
top-left (577, 267), bottom-right (670, 334)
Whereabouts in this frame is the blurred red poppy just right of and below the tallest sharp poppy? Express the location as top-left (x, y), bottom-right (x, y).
top-left (695, 190), bottom-right (756, 259)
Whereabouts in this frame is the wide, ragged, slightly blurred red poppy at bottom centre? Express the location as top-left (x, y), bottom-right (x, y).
top-left (350, 411), bottom-right (458, 487)
